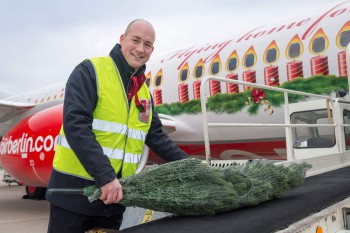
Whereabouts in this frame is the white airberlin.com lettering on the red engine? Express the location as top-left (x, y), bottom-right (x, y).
top-left (0, 133), bottom-right (58, 155)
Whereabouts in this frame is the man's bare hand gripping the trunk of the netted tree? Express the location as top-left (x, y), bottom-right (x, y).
top-left (100, 179), bottom-right (123, 205)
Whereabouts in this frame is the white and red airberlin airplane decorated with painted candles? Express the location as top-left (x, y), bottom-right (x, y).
top-left (0, 1), bottom-right (350, 198)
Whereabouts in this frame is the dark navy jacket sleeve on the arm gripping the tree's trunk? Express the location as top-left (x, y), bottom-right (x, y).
top-left (63, 60), bottom-right (117, 187)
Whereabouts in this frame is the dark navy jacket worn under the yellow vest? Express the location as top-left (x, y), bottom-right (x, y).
top-left (46, 44), bottom-right (188, 216)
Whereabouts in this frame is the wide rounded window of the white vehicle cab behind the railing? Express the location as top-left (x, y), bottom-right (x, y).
top-left (291, 109), bottom-right (335, 149)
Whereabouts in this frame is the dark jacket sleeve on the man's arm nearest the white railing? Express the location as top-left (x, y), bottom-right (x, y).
top-left (146, 99), bottom-right (188, 162)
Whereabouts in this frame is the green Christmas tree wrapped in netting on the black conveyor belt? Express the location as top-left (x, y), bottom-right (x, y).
top-left (84, 158), bottom-right (311, 215)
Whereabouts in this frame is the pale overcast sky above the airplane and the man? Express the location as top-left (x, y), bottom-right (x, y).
top-left (0, 0), bottom-right (333, 98)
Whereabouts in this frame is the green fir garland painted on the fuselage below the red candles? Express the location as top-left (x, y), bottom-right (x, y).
top-left (155, 75), bottom-right (348, 116)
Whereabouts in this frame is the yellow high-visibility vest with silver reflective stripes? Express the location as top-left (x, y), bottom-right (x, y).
top-left (53, 56), bottom-right (152, 180)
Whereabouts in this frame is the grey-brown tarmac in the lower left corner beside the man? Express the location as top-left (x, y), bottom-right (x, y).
top-left (0, 168), bottom-right (50, 233)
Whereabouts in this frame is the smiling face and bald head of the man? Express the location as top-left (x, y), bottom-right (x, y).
top-left (120, 21), bottom-right (155, 69)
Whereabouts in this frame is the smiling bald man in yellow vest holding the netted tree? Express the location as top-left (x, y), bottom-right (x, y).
top-left (46, 19), bottom-right (188, 233)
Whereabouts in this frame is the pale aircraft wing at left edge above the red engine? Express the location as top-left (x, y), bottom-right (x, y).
top-left (0, 100), bottom-right (36, 123)
